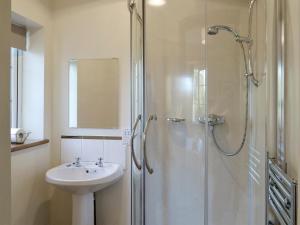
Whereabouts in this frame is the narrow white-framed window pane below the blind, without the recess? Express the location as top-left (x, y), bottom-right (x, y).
top-left (10, 48), bottom-right (23, 128)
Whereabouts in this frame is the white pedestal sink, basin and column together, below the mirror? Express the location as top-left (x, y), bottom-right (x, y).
top-left (46, 162), bottom-right (123, 225)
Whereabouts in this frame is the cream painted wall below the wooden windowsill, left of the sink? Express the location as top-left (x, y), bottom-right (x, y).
top-left (11, 145), bottom-right (50, 225)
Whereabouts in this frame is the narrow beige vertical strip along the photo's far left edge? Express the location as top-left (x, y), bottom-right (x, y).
top-left (0, 0), bottom-right (11, 225)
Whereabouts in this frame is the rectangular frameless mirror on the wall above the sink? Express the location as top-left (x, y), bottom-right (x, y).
top-left (69, 58), bottom-right (120, 129)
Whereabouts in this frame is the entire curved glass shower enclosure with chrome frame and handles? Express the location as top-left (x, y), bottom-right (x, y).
top-left (128, 0), bottom-right (267, 225)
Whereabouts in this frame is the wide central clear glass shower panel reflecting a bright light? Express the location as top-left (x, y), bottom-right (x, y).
top-left (145, 0), bottom-right (206, 225)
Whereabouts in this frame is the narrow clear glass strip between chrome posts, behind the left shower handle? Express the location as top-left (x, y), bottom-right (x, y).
top-left (131, 1), bottom-right (144, 225)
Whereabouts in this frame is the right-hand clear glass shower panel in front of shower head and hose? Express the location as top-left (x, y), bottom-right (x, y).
top-left (207, 0), bottom-right (266, 225)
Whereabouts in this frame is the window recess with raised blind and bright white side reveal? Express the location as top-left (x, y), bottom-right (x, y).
top-left (10, 22), bottom-right (45, 139)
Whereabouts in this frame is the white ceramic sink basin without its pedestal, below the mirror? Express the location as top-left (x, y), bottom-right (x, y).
top-left (46, 162), bottom-right (123, 194)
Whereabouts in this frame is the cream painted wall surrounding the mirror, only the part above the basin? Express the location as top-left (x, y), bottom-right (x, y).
top-left (52, 0), bottom-right (130, 164)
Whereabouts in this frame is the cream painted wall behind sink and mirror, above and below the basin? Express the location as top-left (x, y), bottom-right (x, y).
top-left (51, 0), bottom-right (130, 225)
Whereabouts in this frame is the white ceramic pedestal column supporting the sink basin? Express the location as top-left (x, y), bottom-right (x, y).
top-left (72, 193), bottom-right (94, 225)
